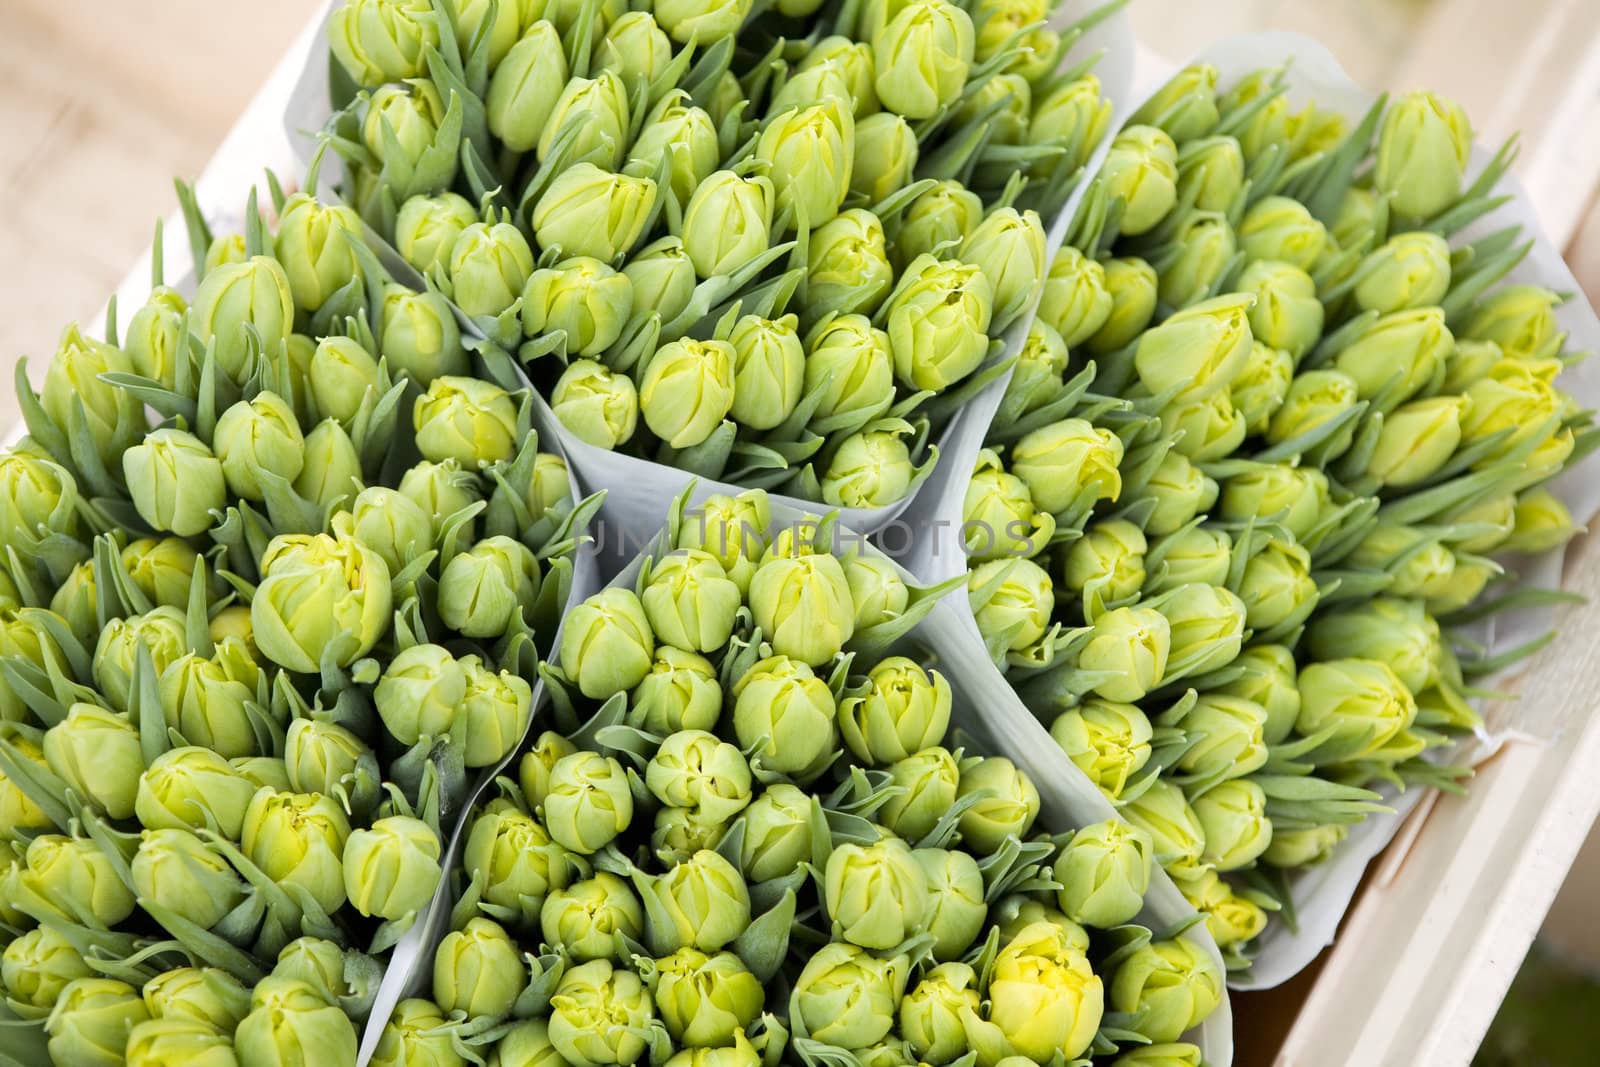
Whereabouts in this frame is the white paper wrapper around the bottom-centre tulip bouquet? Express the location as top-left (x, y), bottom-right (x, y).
top-left (377, 499), bottom-right (1234, 1067)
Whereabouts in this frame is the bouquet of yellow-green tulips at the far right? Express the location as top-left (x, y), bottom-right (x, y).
top-left (965, 66), bottom-right (1600, 966)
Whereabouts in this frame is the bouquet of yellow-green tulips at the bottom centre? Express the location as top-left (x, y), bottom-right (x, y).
top-left (374, 491), bottom-right (1224, 1067)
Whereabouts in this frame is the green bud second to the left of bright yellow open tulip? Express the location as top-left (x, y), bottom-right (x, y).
top-left (789, 942), bottom-right (907, 1048)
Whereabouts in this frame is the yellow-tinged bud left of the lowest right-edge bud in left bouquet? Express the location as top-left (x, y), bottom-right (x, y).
top-left (240, 789), bottom-right (350, 915)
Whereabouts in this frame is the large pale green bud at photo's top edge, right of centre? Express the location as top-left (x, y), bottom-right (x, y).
top-left (872, 0), bottom-right (974, 118)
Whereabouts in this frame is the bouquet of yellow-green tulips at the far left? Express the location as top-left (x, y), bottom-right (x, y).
top-left (0, 186), bottom-right (598, 1065)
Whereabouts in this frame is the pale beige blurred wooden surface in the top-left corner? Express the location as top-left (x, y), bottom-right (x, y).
top-left (0, 0), bottom-right (322, 427)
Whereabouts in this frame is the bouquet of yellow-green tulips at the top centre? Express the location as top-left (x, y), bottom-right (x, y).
top-left (325, 0), bottom-right (1117, 507)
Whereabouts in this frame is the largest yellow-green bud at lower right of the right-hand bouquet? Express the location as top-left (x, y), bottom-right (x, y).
top-left (1294, 659), bottom-right (1416, 761)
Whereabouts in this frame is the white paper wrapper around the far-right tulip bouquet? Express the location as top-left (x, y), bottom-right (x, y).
top-left (888, 32), bottom-right (1600, 989)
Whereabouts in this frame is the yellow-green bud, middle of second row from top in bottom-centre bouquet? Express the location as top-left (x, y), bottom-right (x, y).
top-left (749, 555), bottom-right (856, 667)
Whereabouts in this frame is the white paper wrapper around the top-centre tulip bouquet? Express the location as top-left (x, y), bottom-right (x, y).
top-left (283, 0), bottom-right (1134, 537)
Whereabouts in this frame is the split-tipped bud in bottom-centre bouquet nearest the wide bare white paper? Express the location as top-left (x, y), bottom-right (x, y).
top-left (838, 656), bottom-right (950, 767)
